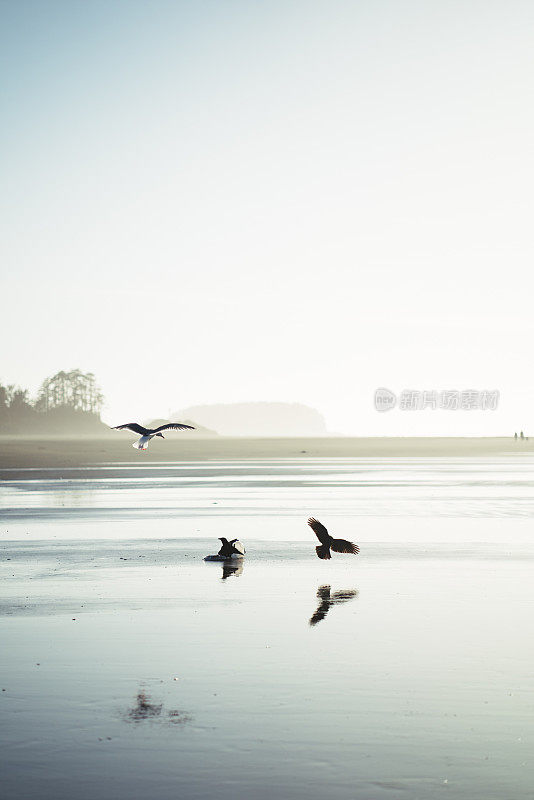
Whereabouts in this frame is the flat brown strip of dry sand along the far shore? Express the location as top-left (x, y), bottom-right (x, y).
top-left (0, 434), bottom-right (534, 480)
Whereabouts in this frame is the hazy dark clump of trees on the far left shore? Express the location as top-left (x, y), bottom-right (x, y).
top-left (0, 369), bottom-right (108, 433)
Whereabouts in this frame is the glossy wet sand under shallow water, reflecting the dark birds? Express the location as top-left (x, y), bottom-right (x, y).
top-left (0, 458), bottom-right (534, 800)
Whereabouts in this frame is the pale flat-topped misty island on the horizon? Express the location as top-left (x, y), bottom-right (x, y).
top-left (171, 402), bottom-right (327, 437)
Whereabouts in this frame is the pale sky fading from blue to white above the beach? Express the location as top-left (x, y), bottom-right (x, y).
top-left (0, 0), bottom-right (534, 435)
